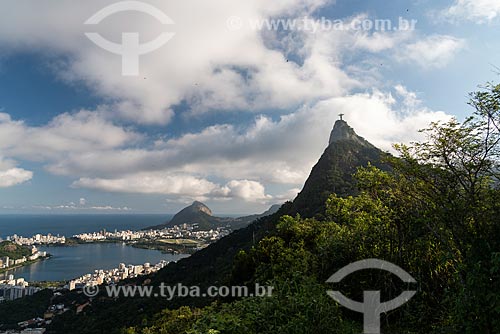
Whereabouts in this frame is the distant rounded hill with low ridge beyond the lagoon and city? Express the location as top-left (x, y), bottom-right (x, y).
top-left (146, 201), bottom-right (281, 230)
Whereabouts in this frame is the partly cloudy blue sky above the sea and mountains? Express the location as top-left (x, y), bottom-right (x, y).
top-left (0, 0), bottom-right (500, 214)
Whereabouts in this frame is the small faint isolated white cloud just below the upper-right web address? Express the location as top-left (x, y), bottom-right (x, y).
top-left (396, 35), bottom-right (465, 69)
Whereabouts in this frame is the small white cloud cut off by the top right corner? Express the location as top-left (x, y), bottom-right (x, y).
top-left (444, 0), bottom-right (500, 24)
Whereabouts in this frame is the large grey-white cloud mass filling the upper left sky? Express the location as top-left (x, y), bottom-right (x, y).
top-left (0, 0), bottom-right (347, 124)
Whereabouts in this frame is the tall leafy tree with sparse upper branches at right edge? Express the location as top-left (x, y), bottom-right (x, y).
top-left (393, 84), bottom-right (500, 333)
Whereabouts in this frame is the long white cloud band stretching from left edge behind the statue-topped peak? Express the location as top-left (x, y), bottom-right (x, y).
top-left (0, 80), bottom-right (448, 204)
